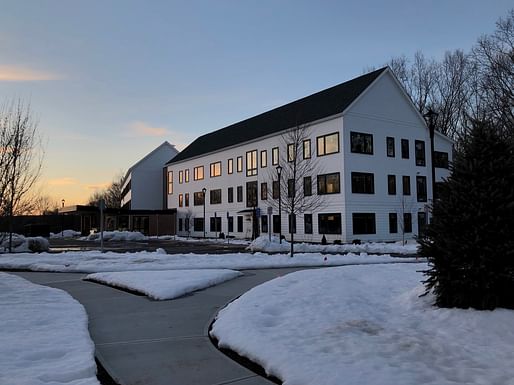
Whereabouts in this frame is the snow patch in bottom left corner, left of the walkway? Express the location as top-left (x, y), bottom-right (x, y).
top-left (0, 273), bottom-right (99, 385)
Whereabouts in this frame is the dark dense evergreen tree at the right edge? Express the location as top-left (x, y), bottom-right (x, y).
top-left (420, 122), bottom-right (514, 309)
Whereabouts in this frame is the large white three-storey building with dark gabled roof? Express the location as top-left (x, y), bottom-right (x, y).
top-left (168, 68), bottom-right (453, 242)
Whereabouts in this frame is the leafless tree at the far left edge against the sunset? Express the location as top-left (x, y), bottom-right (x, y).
top-left (0, 100), bottom-right (44, 252)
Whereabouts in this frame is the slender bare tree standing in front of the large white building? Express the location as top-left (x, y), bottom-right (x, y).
top-left (268, 124), bottom-right (324, 257)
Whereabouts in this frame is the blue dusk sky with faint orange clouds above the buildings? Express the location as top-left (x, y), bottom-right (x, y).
top-left (0, 0), bottom-right (514, 205)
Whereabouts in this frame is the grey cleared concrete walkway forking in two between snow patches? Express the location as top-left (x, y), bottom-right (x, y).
top-left (14, 269), bottom-right (300, 385)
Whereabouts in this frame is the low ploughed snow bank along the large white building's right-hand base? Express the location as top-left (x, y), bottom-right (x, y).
top-left (248, 235), bottom-right (418, 255)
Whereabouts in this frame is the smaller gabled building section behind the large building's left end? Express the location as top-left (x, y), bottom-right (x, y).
top-left (121, 141), bottom-right (178, 210)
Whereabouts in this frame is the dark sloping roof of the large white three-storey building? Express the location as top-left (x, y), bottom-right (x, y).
top-left (167, 67), bottom-right (387, 164)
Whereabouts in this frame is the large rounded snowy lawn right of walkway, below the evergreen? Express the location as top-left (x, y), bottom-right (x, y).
top-left (212, 264), bottom-right (514, 385)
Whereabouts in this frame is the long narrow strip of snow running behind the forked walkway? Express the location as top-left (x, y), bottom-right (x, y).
top-left (0, 249), bottom-right (417, 273)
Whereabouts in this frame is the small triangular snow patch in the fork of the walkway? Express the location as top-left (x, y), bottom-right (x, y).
top-left (85, 269), bottom-right (242, 300)
